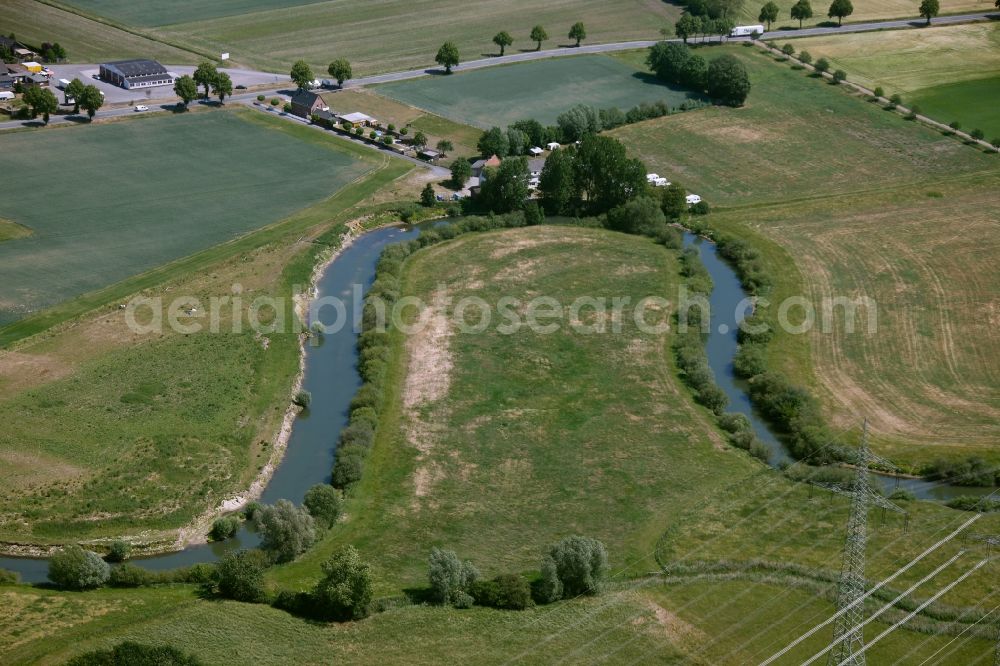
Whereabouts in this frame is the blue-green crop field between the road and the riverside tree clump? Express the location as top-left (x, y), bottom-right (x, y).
top-left (373, 55), bottom-right (708, 127)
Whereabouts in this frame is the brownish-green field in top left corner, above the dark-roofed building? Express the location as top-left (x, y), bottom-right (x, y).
top-left (0, 0), bottom-right (200, 65)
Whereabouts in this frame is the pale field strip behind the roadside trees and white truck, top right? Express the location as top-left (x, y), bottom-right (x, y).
top-left (740, 0), bottom-right (993, 29)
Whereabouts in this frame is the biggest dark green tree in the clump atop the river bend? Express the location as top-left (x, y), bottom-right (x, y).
top-left (573, 134), bottom-right (646, 215)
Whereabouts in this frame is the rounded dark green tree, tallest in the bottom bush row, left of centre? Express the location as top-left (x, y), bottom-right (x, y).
top-left (312, 546), bottom-right (373, 621)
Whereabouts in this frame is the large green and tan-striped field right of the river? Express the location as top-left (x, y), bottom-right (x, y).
top-left (614, 48), bottom-right (1000, 467)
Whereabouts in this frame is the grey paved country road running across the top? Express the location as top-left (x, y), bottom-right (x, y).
top-left (0, 10), bottom-right (1000, 130)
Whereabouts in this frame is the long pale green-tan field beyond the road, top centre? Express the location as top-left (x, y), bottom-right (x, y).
top-left (50, 0), bottom-right (680, 75)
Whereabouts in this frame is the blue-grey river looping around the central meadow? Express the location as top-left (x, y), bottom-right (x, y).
top-left (0, 227), bottom-right (992, 583)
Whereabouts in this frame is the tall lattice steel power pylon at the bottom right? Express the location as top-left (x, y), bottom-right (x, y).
top-left (824, 419), bottom-right (906, 666)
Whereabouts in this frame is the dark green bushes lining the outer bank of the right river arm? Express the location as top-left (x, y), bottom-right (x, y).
top-left (684, 217), bottom-right (1000, 504)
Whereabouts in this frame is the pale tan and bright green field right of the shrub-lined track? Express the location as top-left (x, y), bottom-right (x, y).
top-left (794, 23), bottom-right (1000, 139)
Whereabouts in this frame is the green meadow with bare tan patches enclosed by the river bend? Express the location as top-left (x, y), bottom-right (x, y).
top-left (277, 226), bottom-right (753, 590)
